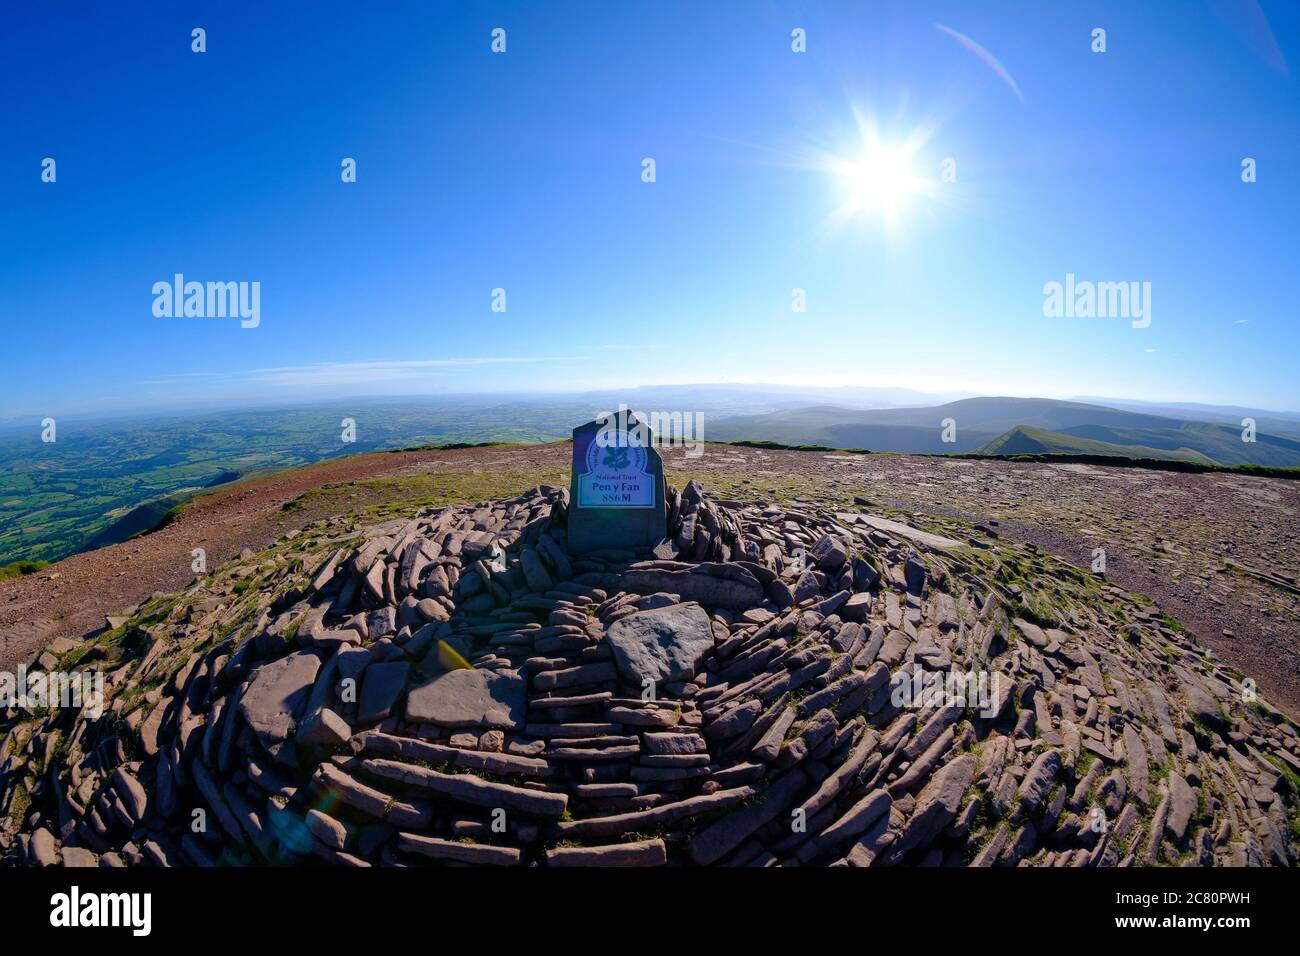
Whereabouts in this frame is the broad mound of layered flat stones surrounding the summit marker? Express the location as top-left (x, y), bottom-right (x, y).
top-left (0, 483), bottom-right (1300, 866)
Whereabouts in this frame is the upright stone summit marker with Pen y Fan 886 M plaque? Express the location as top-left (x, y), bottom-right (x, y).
top-left (568, 410), bottom-right (668, 554)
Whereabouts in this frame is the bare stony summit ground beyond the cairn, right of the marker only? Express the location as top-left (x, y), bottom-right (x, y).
top-left (690, 447), bottom-right (1300, 717)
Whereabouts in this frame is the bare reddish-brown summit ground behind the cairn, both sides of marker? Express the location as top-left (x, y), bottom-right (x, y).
top-left (0, 445), bottom-right (1300, 714)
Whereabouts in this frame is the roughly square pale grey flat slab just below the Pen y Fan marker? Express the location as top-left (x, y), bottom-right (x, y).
top-left (606, 604), bottom-right (714, 685)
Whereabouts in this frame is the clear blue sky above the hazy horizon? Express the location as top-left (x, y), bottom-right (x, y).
top-left (0, 0), bottom-right (1300, 419)
